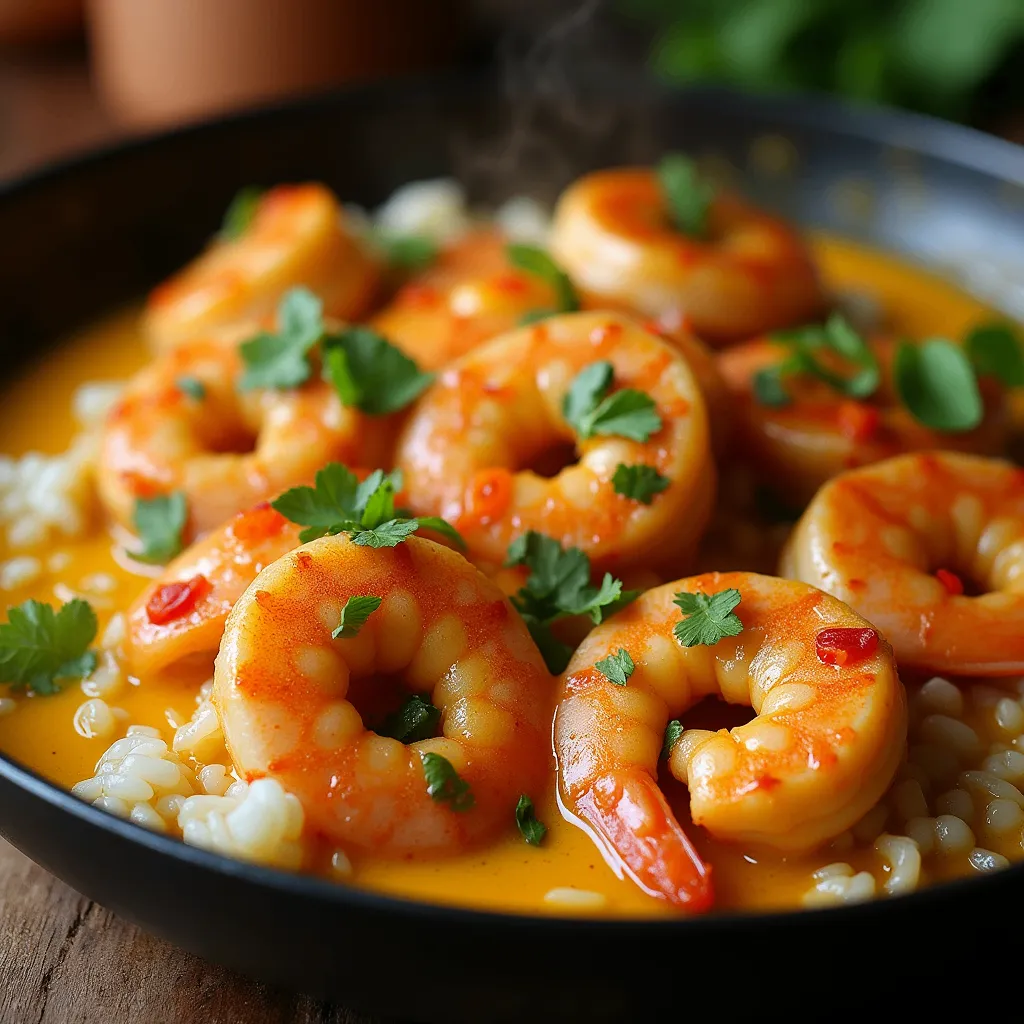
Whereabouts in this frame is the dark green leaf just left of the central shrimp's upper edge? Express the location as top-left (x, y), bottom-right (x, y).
top-left (324, 327), bottom-right (434, 416)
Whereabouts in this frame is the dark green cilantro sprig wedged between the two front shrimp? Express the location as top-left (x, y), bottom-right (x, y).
top-left (505, 530), bottom-right (639, 673)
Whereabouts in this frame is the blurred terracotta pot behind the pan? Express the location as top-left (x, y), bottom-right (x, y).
top-left (89, 0), bottom-right (463, 125)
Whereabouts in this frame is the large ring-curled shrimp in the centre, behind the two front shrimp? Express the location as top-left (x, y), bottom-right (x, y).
top-left (396, 312), bottom-right (715, 571)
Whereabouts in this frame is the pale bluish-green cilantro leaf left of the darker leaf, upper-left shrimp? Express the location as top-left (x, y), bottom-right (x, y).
top-left (239, 288), bottom-right (324, 391)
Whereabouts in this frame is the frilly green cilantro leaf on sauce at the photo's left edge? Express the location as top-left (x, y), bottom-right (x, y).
top-left (0, 598), bottom-right (97, 696)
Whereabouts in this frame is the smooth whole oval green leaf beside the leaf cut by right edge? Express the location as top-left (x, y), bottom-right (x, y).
top-left (893, 338), bottom-right (985, 433)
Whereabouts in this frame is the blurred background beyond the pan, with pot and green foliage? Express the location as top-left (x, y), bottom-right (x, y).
top-left (0, 0), bottom-right (1024, 178)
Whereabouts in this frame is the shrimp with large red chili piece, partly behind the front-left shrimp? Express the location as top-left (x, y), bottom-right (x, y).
top-left (125, 502), bottom-right (302, 675)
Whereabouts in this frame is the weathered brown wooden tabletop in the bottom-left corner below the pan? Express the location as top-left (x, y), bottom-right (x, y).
top-left (0, 840), bottom-right (369, 1024)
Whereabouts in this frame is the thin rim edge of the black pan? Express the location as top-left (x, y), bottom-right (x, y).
top-left (0, 72), bottom-right (1024, 940)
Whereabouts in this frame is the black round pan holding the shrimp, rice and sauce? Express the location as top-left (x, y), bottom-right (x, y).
top-left (0, 79), bottom-right (1024, 1021)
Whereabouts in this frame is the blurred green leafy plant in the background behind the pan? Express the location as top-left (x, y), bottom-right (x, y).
top-left (618, 0), bottom-right (1024, 120)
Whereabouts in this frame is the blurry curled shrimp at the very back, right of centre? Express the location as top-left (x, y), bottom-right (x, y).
top-left (551, 168), bottom-right (823, 344)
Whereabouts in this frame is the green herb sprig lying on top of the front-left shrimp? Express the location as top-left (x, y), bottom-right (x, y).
top-left (270, 462), bottom-right (465, 548)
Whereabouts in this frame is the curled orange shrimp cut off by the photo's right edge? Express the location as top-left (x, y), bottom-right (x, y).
top-left (780, 452), bottom-right (1024, 676)
